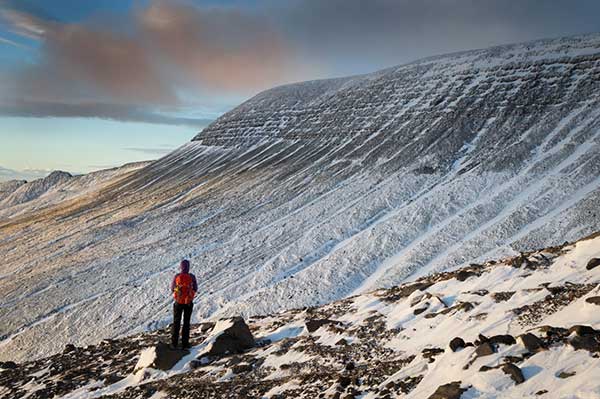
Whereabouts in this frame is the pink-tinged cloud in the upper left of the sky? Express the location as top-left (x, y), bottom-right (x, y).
top-left (0, 1), bottom-right (307, 123)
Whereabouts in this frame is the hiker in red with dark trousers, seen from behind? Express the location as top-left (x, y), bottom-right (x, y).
top-left (171, 259), bottom-right (198, 349)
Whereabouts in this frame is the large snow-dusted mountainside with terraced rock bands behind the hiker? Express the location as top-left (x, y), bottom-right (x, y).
top-left (0, 35), bottom-right (600, 360)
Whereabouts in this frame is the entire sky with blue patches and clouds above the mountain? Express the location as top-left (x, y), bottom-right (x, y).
top-left (0, 0), bottom-right (600, 180)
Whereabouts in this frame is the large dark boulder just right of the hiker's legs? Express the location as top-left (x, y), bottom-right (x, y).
top-left (203, 317), bottom-right (256, 356)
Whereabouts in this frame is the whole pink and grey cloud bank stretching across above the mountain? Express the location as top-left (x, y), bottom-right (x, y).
top-left (0, 0), bottom-right (600, 126)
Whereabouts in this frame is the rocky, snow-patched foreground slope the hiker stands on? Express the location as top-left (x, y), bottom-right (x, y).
top-left (0, 233), bottom-right (600, 399)
